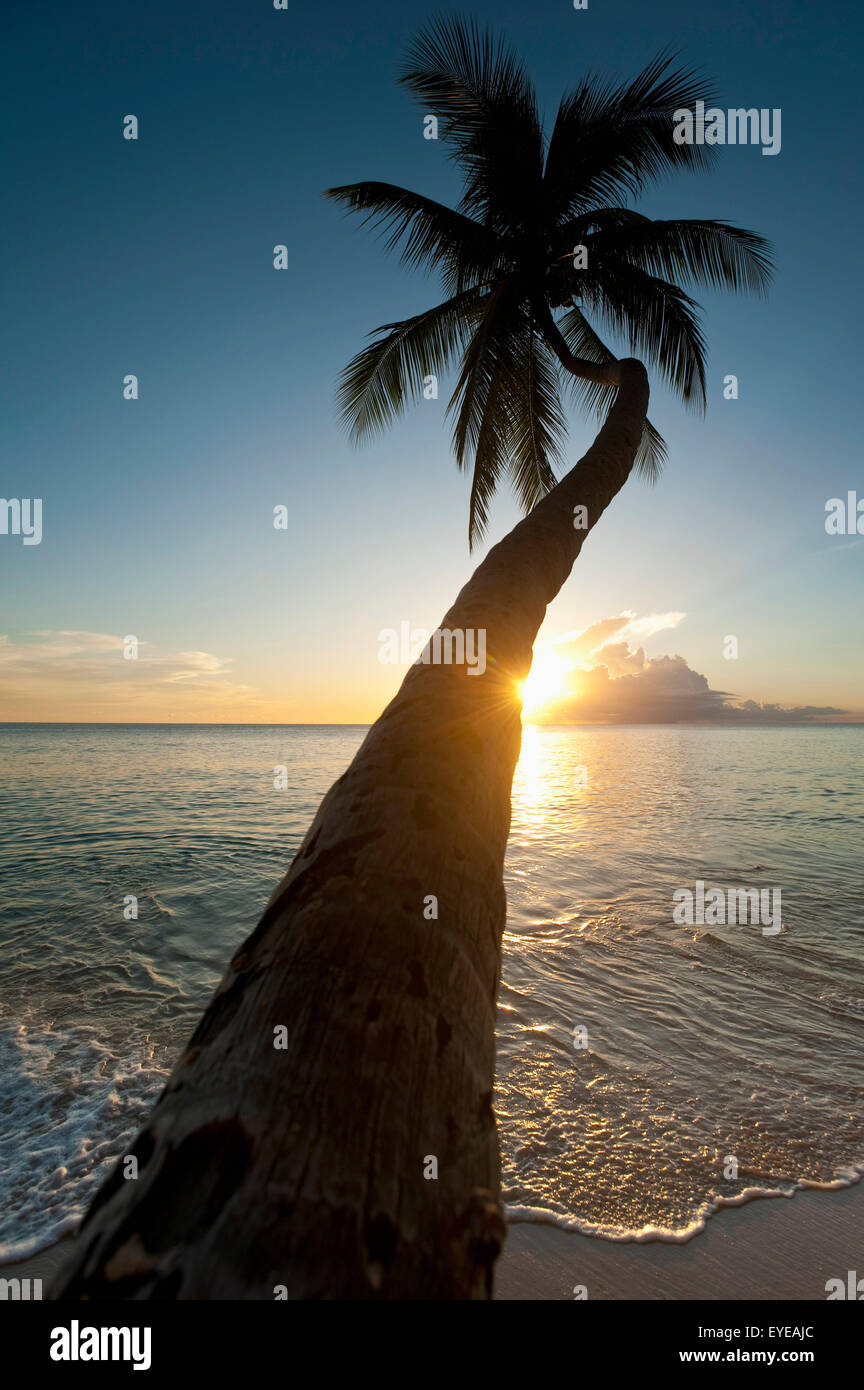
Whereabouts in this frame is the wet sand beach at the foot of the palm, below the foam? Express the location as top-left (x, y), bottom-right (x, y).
top-left (8, 1183), bottom-right (864, 1302)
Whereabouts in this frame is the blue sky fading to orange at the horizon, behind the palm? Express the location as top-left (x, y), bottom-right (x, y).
top-left (0, 0), bottom-right (864, 723)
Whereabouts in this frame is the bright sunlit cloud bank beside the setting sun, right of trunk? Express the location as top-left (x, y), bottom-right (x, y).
top-left (532, 612), bottom-right (850, 724)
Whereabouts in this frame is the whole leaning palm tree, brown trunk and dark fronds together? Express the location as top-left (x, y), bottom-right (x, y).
top-left (51, 21), bottom-right (768, 1300)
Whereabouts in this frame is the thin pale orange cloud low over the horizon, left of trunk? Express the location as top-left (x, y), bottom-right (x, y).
top-left (0, 630), bottom-right (263, 723)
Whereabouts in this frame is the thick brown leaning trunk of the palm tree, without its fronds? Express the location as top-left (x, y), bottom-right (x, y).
top-left (53, 359), bottom-right (647, 1298)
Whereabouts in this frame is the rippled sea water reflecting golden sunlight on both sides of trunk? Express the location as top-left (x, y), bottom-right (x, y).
top-left (0, 726), bottom-right (864, 1259)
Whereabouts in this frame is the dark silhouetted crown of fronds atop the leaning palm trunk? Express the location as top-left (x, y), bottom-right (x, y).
top-left (326, 19), bottom-right (771, 543)
